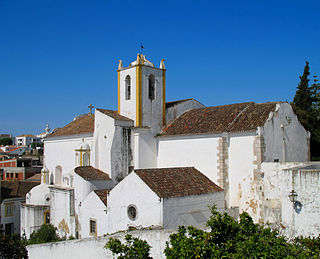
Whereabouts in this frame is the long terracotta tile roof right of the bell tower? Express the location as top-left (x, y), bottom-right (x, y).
top-left (162, 102), bottom-right (277, 135)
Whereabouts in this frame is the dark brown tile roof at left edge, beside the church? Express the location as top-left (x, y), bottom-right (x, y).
top-left (1, 181), bottom-right (40, 199)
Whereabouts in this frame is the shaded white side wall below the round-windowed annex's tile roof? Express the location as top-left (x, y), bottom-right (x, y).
top-left (163, 191), bottom-right (224, 229)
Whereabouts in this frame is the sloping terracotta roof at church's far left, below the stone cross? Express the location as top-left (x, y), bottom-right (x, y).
top-left (47, 114), bottom-right (94, 138)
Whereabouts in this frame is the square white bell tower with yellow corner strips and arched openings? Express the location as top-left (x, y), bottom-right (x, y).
top-left (117, 54), bottom-right (166, 134)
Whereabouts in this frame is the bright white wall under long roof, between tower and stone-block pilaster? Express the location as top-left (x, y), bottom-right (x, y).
top-left (157, 135), bottom-right (218, 182)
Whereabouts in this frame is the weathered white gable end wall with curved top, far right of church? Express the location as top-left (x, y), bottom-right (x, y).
top-left (263, 103), bottom-right (309, 162)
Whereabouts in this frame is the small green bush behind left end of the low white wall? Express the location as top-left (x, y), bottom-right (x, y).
top-left (28, 224), bottom-right (60, 245)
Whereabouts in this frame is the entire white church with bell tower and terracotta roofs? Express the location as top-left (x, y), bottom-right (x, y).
top-left (21, 54), bottom-right (318, 238)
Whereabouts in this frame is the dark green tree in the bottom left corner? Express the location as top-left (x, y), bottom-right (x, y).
top-left (0, 235), bottom-right (28, 259)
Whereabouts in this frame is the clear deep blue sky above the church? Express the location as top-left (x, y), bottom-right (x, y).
top-left (0, 0), bottom-right (320, 136)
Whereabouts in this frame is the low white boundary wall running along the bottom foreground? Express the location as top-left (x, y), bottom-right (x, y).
top-left (27, 230), bottom-right (174, 259)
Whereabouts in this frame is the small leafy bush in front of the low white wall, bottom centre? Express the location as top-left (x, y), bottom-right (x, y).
top-left (105, 235), bottom-right (152, 259)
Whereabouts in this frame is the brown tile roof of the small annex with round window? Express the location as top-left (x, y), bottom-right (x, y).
top-left (135, 167), bottom-right (222, 198)
